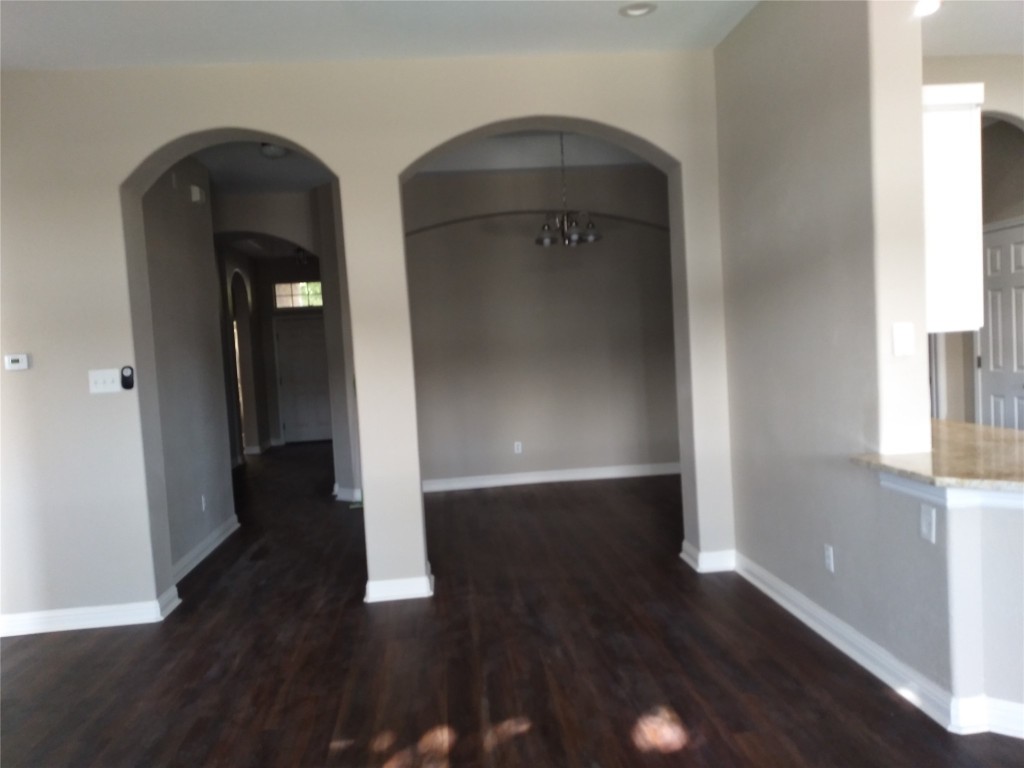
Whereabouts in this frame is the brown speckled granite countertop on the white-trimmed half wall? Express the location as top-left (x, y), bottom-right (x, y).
top-left (854, 420), bottom-right (1024, 493)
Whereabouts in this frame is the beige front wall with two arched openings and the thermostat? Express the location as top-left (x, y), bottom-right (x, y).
top-left (0, 52), bottom-right (732, 611)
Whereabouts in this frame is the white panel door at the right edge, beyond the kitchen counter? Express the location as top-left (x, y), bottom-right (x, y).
top-left (977, 224), bottom-right (1024, 429)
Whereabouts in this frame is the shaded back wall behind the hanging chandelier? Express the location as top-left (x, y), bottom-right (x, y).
top-left (403, 167), bottom-right (679, 479)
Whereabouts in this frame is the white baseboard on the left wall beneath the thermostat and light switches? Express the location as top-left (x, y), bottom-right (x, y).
top-left (0, 587), bottom-right (181, 637)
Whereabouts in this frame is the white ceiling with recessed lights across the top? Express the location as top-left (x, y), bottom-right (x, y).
top-left (0, 0), bottom-right (1024, 70)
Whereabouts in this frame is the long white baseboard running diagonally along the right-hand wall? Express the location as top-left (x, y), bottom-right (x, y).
top-left (736, 554), bottom-right (953, 730)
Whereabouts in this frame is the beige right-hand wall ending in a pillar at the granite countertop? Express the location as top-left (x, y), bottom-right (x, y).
top-left (716, 3), bottom-right (949, 685)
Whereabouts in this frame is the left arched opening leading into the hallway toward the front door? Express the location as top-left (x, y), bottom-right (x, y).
top-left (121, 129), bottom-right (359, 612)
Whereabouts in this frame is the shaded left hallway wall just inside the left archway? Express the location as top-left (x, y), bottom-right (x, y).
top-left (139, 160), bottom-right (234, 563)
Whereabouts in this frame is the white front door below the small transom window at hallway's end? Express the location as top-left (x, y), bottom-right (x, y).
top-left (273, 313), bottom-right (331, 442)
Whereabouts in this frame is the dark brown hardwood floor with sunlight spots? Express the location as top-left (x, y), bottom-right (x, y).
top-left (0, 444), bottom-right (1024, 768)
